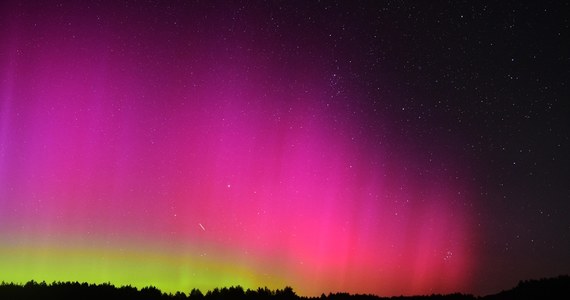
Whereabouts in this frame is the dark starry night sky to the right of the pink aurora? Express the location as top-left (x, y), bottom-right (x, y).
top-left (338, 1), bottom-right (570, 289)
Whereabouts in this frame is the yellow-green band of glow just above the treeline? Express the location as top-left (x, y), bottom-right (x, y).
top-left (0, 233), bottom-right (288, 293)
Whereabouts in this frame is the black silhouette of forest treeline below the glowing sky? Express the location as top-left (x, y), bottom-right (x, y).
top-left (0, 275), bottom-right (570, 300)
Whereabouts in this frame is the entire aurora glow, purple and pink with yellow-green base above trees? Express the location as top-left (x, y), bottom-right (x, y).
top-left (0, 1), bottom-right (475, 295)
